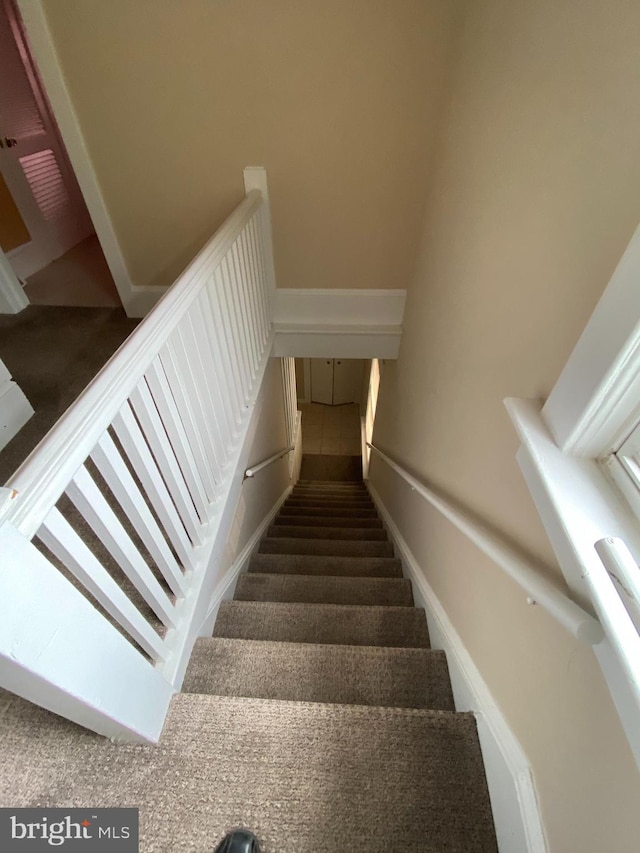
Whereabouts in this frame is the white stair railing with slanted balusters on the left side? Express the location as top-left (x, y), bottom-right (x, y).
top-left (0, 169), bottom-right (274, 740)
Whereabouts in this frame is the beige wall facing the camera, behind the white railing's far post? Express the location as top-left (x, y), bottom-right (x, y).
top-left (44, 0), bottom-right (453, 288)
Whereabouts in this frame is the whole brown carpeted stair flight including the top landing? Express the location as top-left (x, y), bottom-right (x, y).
top-left (0, 462), bottom-right (497, 853)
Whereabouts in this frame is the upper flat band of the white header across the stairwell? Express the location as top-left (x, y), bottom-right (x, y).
top-left (274, 288), bottom-right (407, 326)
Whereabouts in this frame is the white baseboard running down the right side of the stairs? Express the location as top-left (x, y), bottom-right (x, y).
top-left (368, 481), bottom-right (548, 853)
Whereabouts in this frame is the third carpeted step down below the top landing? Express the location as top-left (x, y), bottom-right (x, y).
top-left (233, 572), bottom-right (413, 607)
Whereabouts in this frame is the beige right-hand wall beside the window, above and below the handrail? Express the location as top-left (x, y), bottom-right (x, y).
top-left (372, 0), bottom-right (640, 853)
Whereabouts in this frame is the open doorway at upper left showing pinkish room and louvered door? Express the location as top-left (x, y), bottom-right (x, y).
top-left (0, 0), bottom-right (121, 307)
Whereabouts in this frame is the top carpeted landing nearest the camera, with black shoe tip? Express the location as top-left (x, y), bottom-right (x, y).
top-left (0, 693), bottom-right (497, 853)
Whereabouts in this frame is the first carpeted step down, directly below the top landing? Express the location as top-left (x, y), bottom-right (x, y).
top-left (182, 637), bottom-right (455, 711)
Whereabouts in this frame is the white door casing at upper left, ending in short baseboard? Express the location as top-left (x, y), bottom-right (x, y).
top-left (18, 0), bottom-right (148, 317)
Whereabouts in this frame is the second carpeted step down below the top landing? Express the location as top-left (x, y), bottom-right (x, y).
top-left (213, 601), bottom-right (429, 649)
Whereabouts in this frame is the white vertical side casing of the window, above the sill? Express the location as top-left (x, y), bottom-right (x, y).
top-left (543, 227), bottom-right (640, 457)
